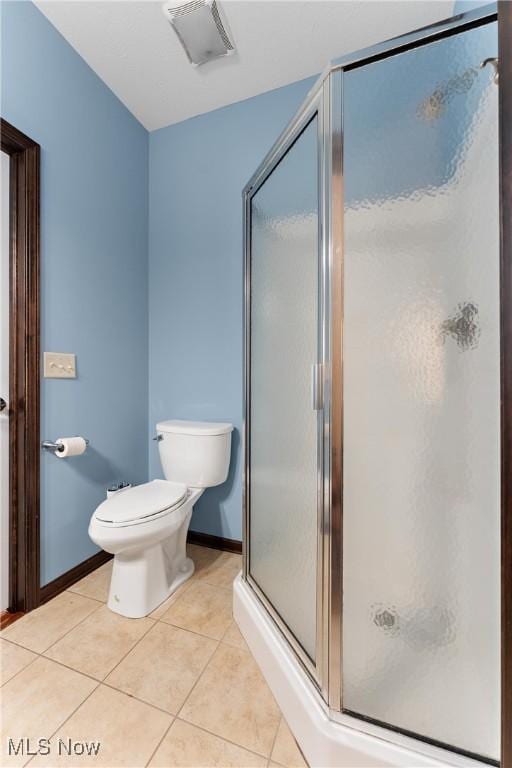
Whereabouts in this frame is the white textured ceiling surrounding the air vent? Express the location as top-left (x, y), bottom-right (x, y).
top-left (36, 0), bottom-right (453, 130)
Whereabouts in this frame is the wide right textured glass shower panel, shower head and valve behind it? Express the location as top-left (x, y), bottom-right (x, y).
top-left (342, 24), bottom-right (500, 760)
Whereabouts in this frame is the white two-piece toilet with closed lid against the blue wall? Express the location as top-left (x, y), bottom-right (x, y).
top-left (89, 420), bottom-right (233, 619)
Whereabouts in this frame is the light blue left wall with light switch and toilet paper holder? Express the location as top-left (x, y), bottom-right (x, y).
top-left (1, 2), bottom-right (148, 584)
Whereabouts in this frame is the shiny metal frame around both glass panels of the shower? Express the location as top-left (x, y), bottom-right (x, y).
top-left (243, 0), bottom-right (512, 768)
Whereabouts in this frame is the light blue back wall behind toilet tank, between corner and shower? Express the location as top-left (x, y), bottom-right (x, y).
top-left (149, 78), bottom-right (315, 539)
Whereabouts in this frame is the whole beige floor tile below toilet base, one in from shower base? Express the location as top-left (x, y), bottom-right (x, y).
top-left (105, 622), bottom-right (217, 714)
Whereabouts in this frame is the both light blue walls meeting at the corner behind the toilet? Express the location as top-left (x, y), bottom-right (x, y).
top-left (1, 1), bottom-right (476, 584)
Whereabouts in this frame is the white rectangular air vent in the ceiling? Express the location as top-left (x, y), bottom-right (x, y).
top-left (162, 0), bottom-right (235, 66)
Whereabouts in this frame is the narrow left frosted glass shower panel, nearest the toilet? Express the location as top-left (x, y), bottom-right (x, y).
top-left (248, 117), bottom-right (318, 660)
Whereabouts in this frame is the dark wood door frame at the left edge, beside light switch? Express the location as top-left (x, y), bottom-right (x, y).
top-left (0, 119), bottom-right (40, 612)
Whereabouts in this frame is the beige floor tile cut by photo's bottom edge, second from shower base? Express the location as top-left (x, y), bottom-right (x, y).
top-left (149, 720), bottom-right (267, 768)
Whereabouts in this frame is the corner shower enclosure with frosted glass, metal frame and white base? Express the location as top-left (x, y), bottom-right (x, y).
top-left (235, 6), bottom-right (512, 766)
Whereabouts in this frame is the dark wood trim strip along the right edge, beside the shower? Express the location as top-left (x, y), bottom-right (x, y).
top-left (498, 0), bottom-right (512, 768)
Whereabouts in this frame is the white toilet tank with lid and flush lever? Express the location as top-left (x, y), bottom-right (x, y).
top-left (156, 420), bottom-right (233, 488)
